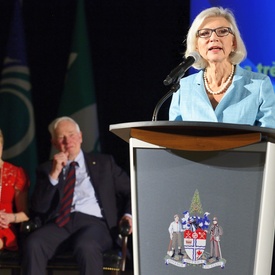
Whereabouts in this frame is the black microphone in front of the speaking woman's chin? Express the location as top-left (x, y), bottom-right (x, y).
top-left (163, 52), bottom-right (201, 86)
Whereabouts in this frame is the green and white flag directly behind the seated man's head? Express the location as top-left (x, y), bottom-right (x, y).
top-left (55, 0), bottom-right (99, 152)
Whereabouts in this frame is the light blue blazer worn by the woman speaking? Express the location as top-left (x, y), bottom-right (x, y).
top-left (169, 65), bottom-right (275, 128)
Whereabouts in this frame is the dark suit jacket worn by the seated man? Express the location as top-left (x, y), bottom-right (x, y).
top-left (31, 153), bottom-right (131, 239)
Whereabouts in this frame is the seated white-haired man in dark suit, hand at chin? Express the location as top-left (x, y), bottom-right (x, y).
top-left (22, 117), bottom-right (132, 275)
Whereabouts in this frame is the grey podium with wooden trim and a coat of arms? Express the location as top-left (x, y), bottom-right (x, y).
top-left (110, 121), bottom-right (275, 275)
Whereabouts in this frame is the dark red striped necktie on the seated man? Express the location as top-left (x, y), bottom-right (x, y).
top-left (55, 161), bottom-right (78, 227)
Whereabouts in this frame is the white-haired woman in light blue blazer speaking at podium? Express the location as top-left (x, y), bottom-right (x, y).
top-left (169, 7), bottom-right (275, 128)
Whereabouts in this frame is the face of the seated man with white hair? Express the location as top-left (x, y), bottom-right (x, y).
top-left (53, 120), bottom-right (82, 159)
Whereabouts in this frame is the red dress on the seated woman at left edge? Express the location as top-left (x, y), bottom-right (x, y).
top-left (0, 162), bottom-right (29, 250)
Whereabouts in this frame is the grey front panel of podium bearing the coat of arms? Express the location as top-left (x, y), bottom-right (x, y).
top-left (131, 141), bottom-right (273, 275)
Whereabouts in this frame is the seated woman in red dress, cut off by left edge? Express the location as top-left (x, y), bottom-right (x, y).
top-left (0, 130), bottom-right (29, 250)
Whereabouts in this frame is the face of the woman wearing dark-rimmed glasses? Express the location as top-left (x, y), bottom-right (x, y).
top-left (197, 17), bottom-right (235, 63)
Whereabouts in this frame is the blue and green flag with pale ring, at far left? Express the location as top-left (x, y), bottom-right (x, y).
top-left (0, 0), bottom-right (37, 196)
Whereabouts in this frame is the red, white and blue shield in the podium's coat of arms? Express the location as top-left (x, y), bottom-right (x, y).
top-left (184, 229), bottom-right (206, 261)
